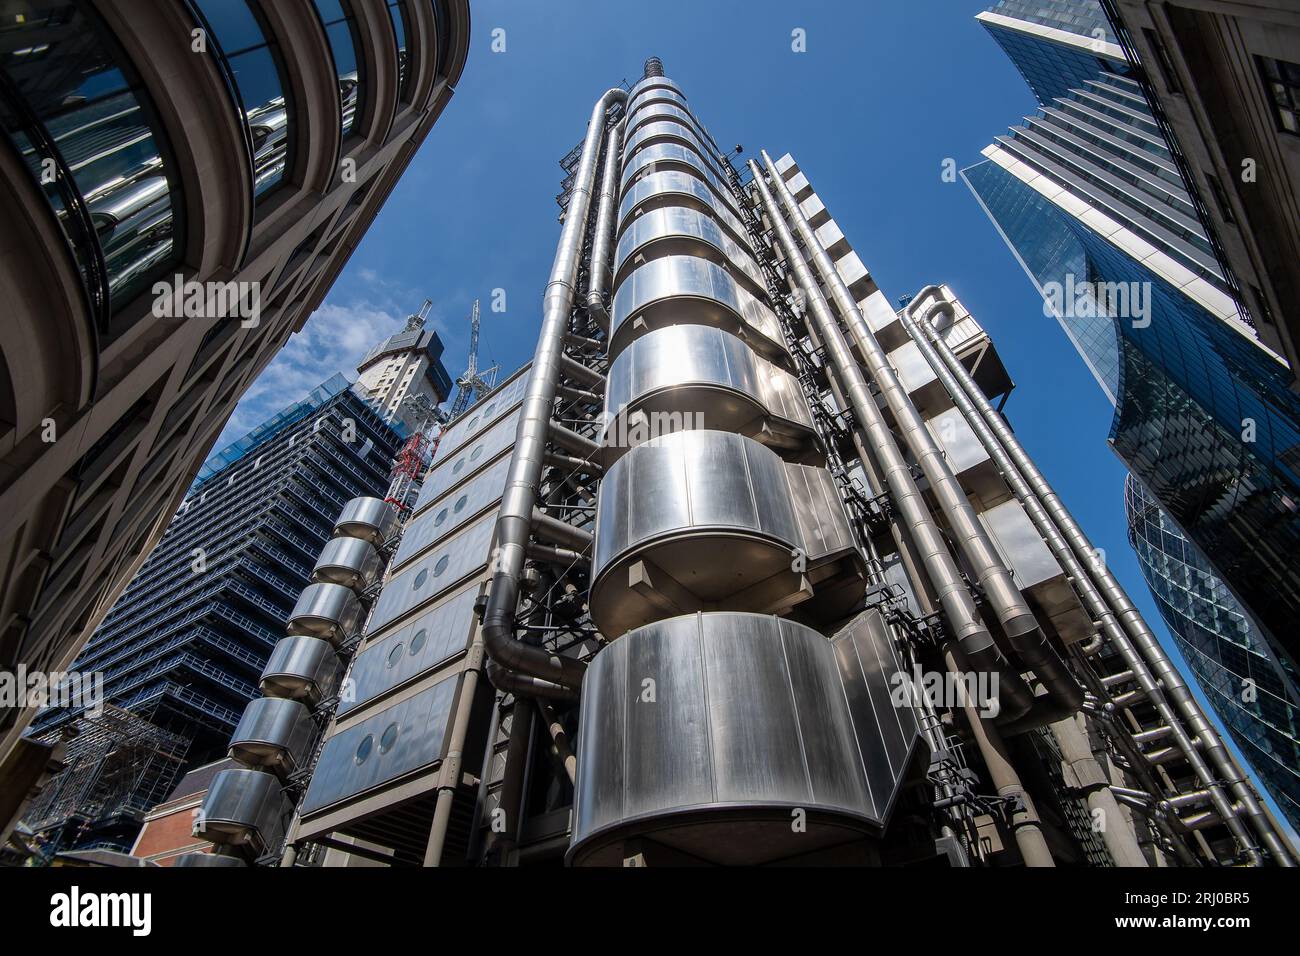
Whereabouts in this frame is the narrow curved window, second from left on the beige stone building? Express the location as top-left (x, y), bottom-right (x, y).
top-left (191, 0), bottom-right (293, 200)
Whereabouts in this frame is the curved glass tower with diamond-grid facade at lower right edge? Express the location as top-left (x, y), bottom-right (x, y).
top-left (1125, 476), bottom-right (1300, 829)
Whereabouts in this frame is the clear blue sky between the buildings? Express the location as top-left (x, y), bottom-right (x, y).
top-left (224, 0), bottom-right (1289, 822)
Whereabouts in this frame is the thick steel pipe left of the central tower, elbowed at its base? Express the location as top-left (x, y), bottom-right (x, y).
top-left (482, 88), bottom-right (628, 697)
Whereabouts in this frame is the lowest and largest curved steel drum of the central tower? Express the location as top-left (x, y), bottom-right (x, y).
top-left (573, 611), bottom-right (897, 863)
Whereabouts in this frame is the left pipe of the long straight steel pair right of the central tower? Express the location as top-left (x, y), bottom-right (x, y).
top-left (749, 160), bottom-right (1032, 719)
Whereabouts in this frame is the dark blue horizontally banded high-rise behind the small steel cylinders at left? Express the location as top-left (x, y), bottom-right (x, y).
top-left (29, 375), bottom-right (403, 851)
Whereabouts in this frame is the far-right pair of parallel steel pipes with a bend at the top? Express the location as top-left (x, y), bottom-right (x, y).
top-left (900, 285), bottom-right (1294, 866)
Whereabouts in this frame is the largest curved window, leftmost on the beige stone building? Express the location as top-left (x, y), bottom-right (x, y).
top-left (0, 0), bottom-right (183, 321)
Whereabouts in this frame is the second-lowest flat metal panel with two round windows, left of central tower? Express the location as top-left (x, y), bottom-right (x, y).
top-left (338, 583), bottom-right (480, 714)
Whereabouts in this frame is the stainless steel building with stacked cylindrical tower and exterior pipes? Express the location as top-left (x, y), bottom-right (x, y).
top-left (183, 59), bottom-right (1294, 866)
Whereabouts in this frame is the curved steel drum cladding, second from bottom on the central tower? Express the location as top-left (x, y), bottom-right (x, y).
top-left (593, 431), bottom-right (806, 574)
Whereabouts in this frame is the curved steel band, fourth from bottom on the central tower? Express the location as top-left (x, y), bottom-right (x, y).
top-left (610, 256), bottom-right (785, 351)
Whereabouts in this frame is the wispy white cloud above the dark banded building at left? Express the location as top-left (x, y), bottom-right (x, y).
top-left (216, 303), bottom-right (406, 449)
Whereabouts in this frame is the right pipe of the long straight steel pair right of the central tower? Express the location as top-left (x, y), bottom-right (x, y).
top-left (761, 150), bottom-right (1083, 706)
